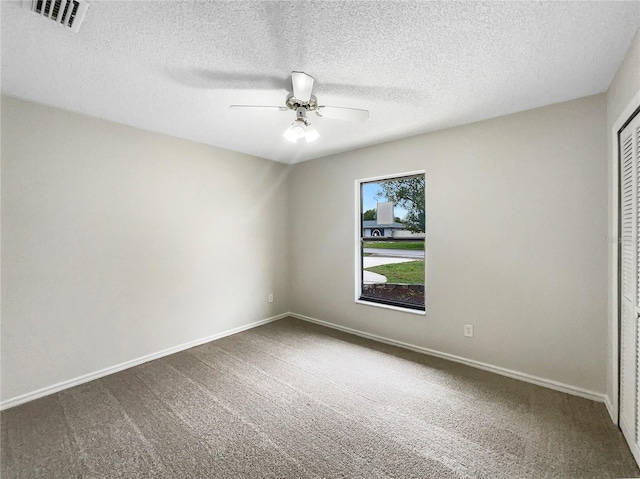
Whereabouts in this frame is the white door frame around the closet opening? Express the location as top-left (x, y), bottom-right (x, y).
top-left (605, 90), bottom-right (640, 427)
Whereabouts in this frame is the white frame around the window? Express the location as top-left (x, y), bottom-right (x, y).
top-left (354, 170), bottom-right (427, 316)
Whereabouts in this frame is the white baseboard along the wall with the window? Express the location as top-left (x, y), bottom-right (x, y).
top-left (289, 313), bottom-right (606, 403)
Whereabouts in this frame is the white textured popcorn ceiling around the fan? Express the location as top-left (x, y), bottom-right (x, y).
top-left (0, 1), bottom-right (640, 163)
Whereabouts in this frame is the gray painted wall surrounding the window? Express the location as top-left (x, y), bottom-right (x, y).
top-left (290, 94), bottom-right (607, 394)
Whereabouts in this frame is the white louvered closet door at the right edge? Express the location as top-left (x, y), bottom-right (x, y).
top-left (620, 110), bottom-right (640, 460)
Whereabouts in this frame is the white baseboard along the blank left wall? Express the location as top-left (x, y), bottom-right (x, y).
top-left (0, 313), bottom-right (290, 411)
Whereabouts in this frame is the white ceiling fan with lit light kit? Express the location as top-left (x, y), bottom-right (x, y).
top-left (229, 72), bottom-right (369, 143)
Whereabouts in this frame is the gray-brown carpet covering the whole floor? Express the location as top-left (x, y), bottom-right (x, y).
top-left (1, 319), bottom-right (640, 479)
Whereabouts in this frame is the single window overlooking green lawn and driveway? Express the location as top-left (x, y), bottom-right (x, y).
top-left (356, 173), bottom-right (426, 311)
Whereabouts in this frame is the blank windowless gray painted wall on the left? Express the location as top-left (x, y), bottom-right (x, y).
top-left (1, 97), bottom-right (289, 400)
